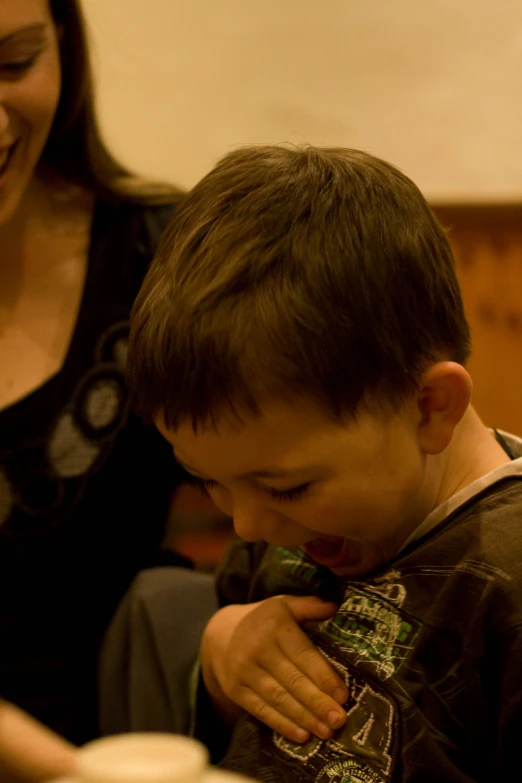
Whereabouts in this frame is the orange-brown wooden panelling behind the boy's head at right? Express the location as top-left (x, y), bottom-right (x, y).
top-left (435, 205), bottom-right (522, 435)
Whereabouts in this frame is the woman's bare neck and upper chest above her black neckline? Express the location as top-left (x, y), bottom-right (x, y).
top-left (0, 175), bottom-right (93, 410)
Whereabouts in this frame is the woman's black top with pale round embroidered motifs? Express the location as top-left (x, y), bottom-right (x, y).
top-left (0, 202), bottom-right (190, 742)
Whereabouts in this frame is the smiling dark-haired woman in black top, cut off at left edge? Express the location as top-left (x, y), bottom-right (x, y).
top-left (0, 0), bottom-right (191, 743)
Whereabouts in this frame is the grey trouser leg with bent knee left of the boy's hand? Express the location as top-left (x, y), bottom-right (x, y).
top-left (99, 568), bottom-right (217, 734)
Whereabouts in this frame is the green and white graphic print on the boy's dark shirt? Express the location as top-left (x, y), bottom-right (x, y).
top-left (268, 548), bottom-right (412, 783)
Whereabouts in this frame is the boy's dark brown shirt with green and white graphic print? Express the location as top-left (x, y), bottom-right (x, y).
top-left (208, 475), bottom-right (522, 783)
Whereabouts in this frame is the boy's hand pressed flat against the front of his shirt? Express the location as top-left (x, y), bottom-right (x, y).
top-left (201, 596), bottom-right (348, 742)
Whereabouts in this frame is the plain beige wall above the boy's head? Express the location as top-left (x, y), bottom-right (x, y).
top-left (83, 0), bottom-right (522, 200)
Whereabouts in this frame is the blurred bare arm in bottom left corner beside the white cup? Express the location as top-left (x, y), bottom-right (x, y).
top-left (0, 700), bottom-right (76, 783)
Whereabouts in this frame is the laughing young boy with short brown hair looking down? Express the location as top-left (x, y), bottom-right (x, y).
top-left (129, 147), bottom-right (522, 783)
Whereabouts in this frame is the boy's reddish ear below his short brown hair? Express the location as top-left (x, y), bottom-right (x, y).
top-left (417, 362), bottom-right (473, 454)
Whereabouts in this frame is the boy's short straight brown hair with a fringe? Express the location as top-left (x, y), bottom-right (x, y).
top-left (129, 146), bottom-right (469, 429)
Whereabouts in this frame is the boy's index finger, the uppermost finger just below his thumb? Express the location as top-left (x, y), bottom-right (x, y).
top-left (276, 626), bottom-right (348, 714)
